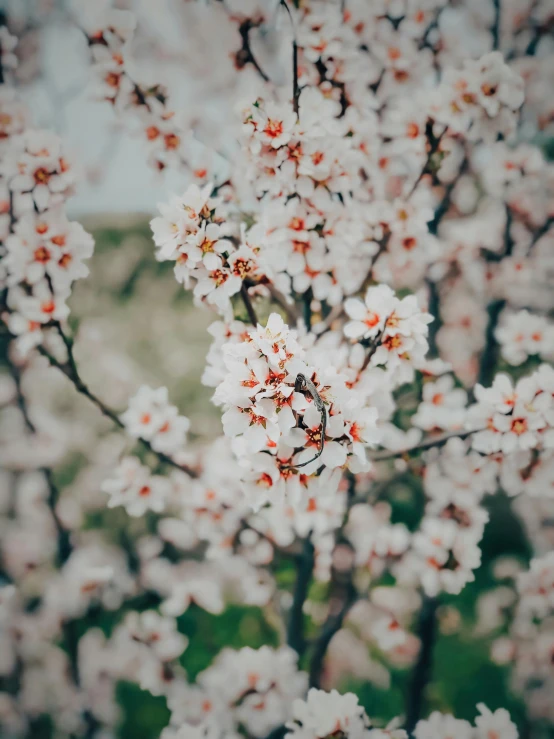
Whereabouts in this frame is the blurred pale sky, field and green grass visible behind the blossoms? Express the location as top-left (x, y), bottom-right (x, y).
top-left (0, 0), bottom-right (549, 739)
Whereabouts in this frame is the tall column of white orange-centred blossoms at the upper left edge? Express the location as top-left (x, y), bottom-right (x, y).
top-left (0, 44), bottom-right (94, 355)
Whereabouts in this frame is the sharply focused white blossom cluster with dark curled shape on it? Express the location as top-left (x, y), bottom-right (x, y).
top-left (214, 313), bottom-right (379, 508)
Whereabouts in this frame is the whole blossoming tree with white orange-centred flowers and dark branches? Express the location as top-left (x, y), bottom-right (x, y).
top-left (0, 0), bottom-right (554, 739)
